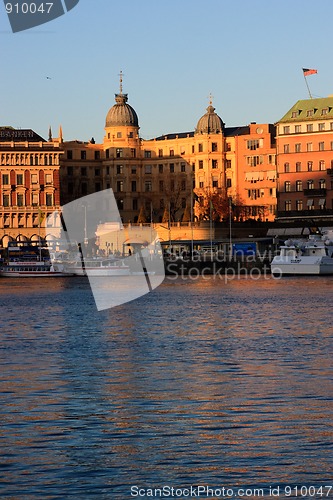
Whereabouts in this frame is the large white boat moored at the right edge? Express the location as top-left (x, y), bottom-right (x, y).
top-left (271, 231), bottom-right (333, 276)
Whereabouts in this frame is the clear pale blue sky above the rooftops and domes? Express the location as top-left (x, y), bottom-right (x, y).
top-left (0, 0), bottom-right (333, 142)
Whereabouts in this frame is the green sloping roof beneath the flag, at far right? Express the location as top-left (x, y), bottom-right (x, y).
top-left (277, 96), bottom-right (333, 123)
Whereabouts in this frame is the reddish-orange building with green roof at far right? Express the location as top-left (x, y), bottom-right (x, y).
top-left (277, 96), bottom-right (333, 221)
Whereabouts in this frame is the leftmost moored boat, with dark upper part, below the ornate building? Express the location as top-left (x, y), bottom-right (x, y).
top-left (0, 260), bottom-right (69, 278)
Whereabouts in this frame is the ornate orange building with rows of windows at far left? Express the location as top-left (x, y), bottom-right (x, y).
top-left (0, 127), bottom-right (62, 245)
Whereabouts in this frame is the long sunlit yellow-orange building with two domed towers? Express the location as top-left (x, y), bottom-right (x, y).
top-left (60, 86), bottom-right (276, 223)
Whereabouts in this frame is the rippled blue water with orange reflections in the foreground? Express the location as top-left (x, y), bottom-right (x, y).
top-left (0, 276), bottom-right (333, 500)
